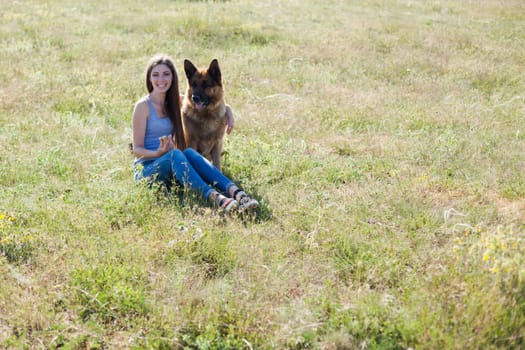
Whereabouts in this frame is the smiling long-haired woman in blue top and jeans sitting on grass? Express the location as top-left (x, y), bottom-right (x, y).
top-left (133, 54), bottom-right (259, 212)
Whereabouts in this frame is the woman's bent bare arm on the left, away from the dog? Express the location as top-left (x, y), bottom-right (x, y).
top-left (133, 101), bottom-right (173, 159)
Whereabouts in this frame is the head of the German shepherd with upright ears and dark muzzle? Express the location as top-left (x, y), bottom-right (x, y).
top-left (184, 59), bottom-right (224, 110)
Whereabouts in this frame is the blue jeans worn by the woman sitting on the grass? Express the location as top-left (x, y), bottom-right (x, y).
top-left (135, 148), bottom-right (234, 198)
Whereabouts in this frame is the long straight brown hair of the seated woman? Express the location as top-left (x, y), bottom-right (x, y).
top-left (146, 54), bottom-right (186, 150)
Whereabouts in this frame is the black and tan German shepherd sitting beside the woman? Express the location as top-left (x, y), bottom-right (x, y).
top-left (182, 59), bottom-right (226, 170)
